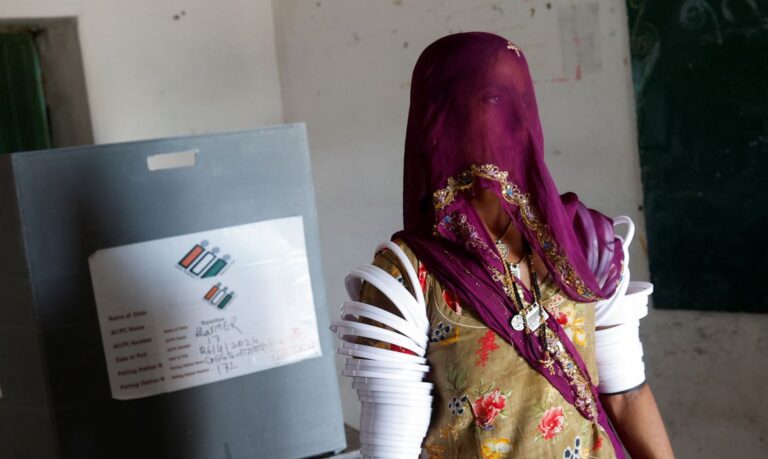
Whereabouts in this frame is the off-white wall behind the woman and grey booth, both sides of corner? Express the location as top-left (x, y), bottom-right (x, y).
top-left (0, 0), bottom-right (768, 458)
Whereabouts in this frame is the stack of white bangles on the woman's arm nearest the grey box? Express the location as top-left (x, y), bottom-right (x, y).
top-left (331, 242), bottom-right (432, 458)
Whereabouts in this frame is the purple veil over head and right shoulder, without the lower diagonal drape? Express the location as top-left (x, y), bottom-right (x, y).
top-left (403, 32), bottom-right (623, 301)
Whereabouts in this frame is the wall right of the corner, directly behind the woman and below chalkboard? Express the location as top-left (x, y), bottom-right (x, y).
top-left (275, 0), bottom-right (768, 457)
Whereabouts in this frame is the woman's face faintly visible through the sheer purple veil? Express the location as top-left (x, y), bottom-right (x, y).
top-left (428, 42), bottom-right (540, 180)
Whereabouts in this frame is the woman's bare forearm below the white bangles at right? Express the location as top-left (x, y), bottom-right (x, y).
top-left (600, 384), bottom-right (674, 459)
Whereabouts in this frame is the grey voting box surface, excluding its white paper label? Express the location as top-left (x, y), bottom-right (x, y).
top-left (0, 124), bottom-right (345, 459)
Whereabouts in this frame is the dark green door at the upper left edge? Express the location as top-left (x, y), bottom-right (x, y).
top-left (0, 33), bottom-right (51, 154)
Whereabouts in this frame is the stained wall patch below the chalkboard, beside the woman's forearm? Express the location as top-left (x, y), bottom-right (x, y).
top-left (640, 309), bottom-right (768, 459)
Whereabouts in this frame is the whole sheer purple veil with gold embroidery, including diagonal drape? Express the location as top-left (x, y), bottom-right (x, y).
top-left (393, 32), bottom-right (623, 457)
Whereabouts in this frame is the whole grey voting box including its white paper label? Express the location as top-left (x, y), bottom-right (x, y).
top-left (0, 124), bottom-right (345, 459)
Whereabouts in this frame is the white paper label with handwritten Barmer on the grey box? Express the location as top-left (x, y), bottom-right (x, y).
top-left (88, 216), bottom-right (321, 400)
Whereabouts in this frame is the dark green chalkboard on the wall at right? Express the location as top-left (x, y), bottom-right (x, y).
top-left (627, 0), bottom-right (768, 312)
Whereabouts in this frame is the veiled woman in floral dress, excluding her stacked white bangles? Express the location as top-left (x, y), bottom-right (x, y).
top-left (354, 32), bottom-right (672, 459)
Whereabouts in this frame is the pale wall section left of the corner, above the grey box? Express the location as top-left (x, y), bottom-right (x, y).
top-left (0, 0), bottom-right (283, 143)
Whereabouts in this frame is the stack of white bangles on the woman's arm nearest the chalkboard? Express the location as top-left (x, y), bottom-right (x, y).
top-left (595, 216), bottom-right (653, 395)
